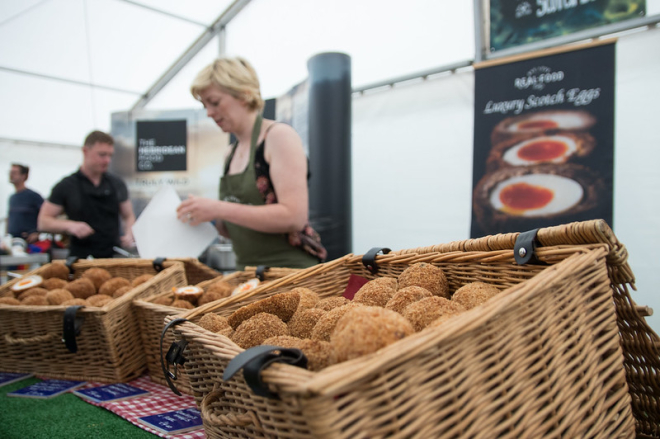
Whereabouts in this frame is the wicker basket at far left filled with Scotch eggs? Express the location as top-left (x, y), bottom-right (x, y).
top-left (0, 259), bottom-right (185, 383)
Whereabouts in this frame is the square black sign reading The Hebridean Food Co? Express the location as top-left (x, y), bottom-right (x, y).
top-left (135, 120), bottom-right (188, 172)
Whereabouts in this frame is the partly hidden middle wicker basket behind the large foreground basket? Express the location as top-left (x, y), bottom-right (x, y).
top-left (133, 266), bottom-right (300, 395)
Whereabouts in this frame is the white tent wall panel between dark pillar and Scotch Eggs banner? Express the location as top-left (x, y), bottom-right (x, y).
top-left (352, 71), bottom-right (474, 253)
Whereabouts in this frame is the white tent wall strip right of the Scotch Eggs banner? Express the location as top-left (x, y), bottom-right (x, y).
top-left (613, 29), bottom-right (660, 334)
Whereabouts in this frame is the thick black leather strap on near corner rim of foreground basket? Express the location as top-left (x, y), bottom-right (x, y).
top-left (222, 345), bottom-right (307, 399)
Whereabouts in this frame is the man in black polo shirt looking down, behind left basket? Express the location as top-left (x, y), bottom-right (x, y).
top-left (38, 131), bottom-right (135, 258)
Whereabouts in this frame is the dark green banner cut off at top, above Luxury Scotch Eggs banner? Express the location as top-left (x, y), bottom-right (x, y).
top-left (490, 0), bottom-right (646, 52)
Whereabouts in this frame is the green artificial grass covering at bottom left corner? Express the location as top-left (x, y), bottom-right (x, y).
top-left (0, 378), bottom-right (157, 439)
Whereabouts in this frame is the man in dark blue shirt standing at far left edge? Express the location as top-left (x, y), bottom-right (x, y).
top-left (7, 163), bottom-right (44, 244)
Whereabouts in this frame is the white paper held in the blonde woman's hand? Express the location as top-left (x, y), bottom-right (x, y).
top-left (133, 186), bottom-right (218, 259)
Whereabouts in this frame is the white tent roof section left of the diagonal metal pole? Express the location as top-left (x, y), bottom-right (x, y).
top-left (0, 0), bottom-right (231, 145)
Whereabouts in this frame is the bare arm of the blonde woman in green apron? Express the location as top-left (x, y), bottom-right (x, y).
top-left (177, 124), bottom-right (308, 233)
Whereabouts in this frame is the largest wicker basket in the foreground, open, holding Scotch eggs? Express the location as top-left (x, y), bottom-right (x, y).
top-left (168, 224), bottom-right (652, 438)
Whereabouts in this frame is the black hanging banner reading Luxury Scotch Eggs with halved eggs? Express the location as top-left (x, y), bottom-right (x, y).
top-left (471, 43), bottom-right (615, 237)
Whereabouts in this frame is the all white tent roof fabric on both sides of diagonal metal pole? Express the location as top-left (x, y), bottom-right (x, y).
top-left (0, 0), bottom-right (474, 145)
